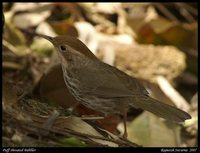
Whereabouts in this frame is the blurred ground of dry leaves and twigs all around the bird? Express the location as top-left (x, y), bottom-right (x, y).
top-left (2, 3), bottom-right (198, 147)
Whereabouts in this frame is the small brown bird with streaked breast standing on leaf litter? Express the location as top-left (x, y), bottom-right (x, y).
top-left (34, 33), bottom-right (191, 138)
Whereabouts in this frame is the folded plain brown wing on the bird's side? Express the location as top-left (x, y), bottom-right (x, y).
top-left (76, 62), bottom-right (148, 98)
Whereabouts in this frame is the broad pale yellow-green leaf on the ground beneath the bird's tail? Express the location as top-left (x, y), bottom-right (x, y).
top-left (128, 112), bottom-right (180, 147)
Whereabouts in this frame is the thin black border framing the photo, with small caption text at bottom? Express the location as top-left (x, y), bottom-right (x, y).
top-left (1, 0), bottom-right (199, 153)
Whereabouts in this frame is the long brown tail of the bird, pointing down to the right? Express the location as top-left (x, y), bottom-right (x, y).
top-left (129, 96), bottom-right (191, 122)
